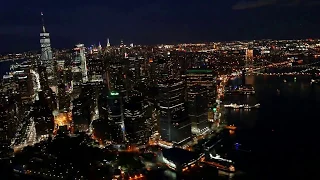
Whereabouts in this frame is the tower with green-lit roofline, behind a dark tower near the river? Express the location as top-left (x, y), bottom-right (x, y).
top-left (186, 69), bottom-right (215, 107)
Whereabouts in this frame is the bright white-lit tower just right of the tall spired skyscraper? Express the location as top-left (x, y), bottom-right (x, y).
top-left (72, 44), bottom-right (88, 85)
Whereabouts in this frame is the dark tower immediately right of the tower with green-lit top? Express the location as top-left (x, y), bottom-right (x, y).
top-left (124, 91), bottom-right (150, 145)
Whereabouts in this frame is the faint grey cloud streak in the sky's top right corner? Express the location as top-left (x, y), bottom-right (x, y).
top-left (232, 0), bottom-right (320, 10)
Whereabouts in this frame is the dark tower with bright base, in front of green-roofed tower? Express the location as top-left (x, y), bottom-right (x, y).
top-left (187, 85), bottom-right (209, 135)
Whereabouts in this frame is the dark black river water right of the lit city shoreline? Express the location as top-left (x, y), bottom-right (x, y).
top-left (224, 76), bottom-right (320, 179)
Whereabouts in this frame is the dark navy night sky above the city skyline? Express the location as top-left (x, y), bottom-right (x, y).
top-left (0, 0), bottom-right (320, 53)
